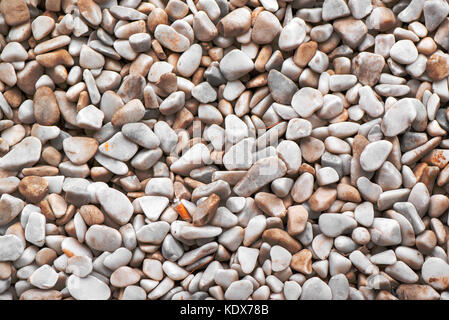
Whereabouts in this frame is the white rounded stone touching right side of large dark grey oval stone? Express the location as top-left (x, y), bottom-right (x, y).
top-left (291, 87), bottom-right (324, 118)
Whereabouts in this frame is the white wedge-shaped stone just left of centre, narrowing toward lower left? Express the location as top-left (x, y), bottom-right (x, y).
top-left (170, 144), bottom-right (210, 176)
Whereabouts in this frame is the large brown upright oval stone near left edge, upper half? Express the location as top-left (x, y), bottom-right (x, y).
top-left (33, 87), bottom-right (60, 126)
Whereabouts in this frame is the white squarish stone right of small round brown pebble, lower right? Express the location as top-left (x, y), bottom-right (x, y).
top-left (370, 218), bottom-right (402, 246)
